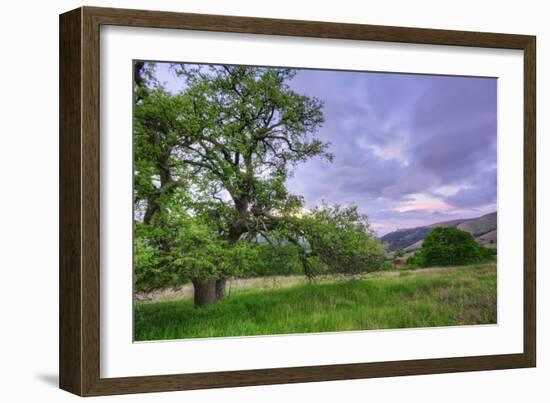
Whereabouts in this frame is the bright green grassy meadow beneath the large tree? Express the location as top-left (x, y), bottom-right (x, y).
top-left (135, 264), bottom-right (497, 341)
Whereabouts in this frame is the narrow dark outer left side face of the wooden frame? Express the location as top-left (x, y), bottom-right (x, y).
top-left (59, 9), bottom-right (83, 395)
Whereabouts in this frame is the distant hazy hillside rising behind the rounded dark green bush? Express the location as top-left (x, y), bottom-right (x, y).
top-left (380, 212), bottom-right (497, 252)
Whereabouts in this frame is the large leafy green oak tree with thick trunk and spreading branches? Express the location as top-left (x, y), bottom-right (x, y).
top-left (134, 64), bottom-right (384, 306)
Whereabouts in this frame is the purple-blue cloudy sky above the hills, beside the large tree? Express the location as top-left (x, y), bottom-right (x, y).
top-left (153, 61), bottom-right (497, 235)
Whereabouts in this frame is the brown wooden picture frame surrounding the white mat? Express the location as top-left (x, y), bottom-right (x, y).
top-left (59, 7), bottom-right (536, 396)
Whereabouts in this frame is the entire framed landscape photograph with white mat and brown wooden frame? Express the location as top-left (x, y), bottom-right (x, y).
top-left (60, 7), bottom-right (536, 396)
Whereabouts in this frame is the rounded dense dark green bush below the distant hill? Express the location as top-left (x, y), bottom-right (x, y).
top-left (407, 227), bottom-right (496, 267)
